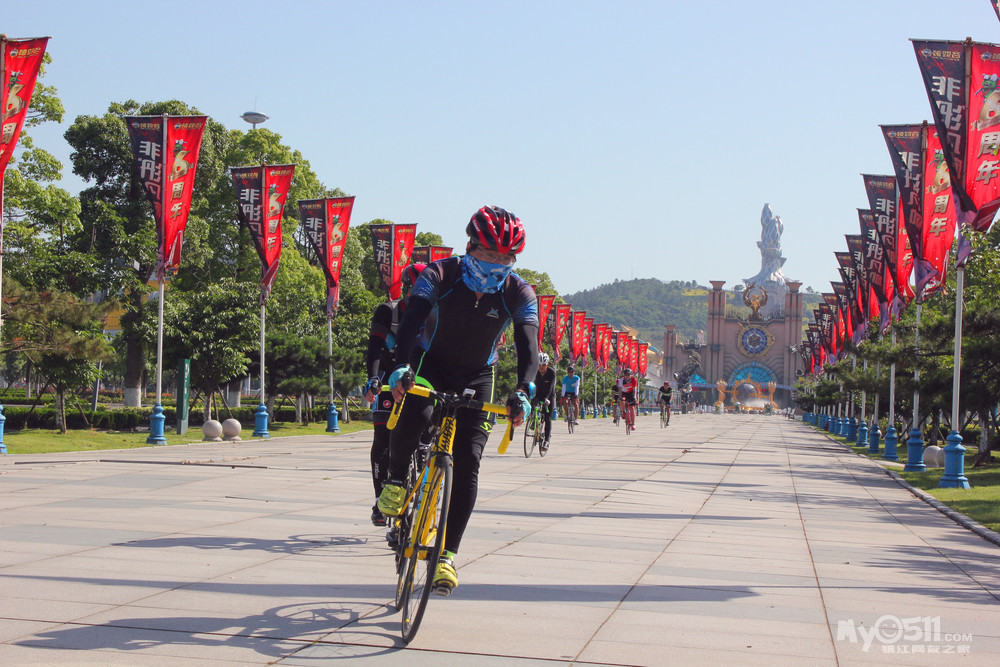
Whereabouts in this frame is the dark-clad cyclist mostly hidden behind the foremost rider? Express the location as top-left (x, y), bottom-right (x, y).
top-left (365, 264), bottom-right (426, 526)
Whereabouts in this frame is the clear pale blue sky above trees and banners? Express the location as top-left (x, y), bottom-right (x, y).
top-left (7, 0), bottom-right (1000, 294)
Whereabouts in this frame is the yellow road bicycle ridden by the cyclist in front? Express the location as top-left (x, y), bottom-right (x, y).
top-left (386, 385), bottom-right (514, 644)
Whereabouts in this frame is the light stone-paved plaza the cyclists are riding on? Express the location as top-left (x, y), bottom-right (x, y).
top-left (0, 415), bottom-right (1000, 667)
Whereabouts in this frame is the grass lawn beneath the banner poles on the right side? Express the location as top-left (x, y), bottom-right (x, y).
top-left (824, 431), bottom-right (1000, 532)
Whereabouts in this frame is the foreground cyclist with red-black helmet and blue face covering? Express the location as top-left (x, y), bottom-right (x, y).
top-left (378, 206), bottom-right (538, 595)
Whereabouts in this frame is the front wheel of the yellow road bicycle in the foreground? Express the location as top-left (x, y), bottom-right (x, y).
top-left (401, 457), bottom-right (452, 644)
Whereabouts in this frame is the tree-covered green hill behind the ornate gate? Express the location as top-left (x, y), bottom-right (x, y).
top-left (563, 278), bottom-right (821, 347)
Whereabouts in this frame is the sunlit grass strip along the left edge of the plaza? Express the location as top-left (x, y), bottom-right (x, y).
top-left (4, 420), bottom-right (372, 454)
